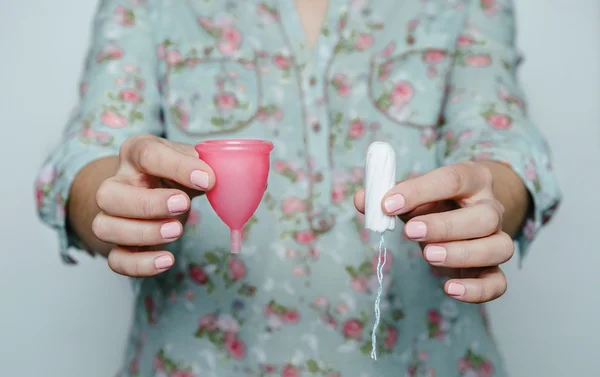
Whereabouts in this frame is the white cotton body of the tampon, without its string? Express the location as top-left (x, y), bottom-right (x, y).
top-left (365, 141), bottom-right (396, 233)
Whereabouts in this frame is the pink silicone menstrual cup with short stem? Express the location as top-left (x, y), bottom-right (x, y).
top-left (196, 139), bottom-right (273, 254)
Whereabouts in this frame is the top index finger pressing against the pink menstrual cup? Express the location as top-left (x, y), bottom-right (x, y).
top-left (122, 137), bottom-right (215, 191)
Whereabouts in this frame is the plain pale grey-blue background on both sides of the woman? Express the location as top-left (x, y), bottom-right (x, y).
top-left (0, 0), bottom-right (600, 377)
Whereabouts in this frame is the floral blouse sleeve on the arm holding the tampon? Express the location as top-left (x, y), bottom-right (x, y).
top-left (438, 1), bottom-right (561, 260)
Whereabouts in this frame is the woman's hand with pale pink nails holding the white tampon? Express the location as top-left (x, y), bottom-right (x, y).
top-left (354, 161), bottom-right (514, 303)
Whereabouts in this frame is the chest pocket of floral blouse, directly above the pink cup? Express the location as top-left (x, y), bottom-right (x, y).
top-left (162, 44), bottom-right (262, 138)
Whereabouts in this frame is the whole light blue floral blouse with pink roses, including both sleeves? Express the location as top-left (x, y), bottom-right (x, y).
top-left (36, 0), bottom-right (560, 377)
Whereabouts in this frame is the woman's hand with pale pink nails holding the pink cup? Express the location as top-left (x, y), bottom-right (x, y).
top-left (92, 135), bottom-right (215, 277)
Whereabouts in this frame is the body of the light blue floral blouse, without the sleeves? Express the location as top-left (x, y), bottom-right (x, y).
top-left (123, 0), bottom-right (504, 377)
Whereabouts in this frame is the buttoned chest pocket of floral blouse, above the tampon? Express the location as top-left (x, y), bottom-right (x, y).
top-left (368, 34), bottom-right (455, 129)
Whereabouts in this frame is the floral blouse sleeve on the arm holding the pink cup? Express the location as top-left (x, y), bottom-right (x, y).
top-left (35, 0), bottom-right (163, 264)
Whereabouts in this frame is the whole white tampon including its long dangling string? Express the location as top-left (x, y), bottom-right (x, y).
top-left (365, 141), bottom-right (396, 360)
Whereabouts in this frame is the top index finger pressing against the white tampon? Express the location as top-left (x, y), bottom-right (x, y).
top-left (382, 161), bottom-right (492, 215)
